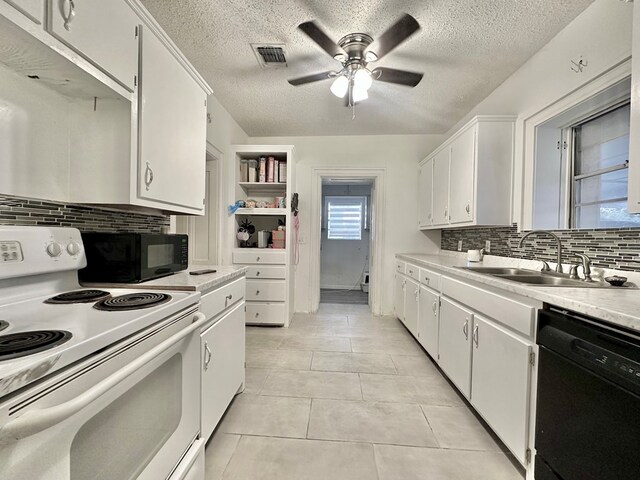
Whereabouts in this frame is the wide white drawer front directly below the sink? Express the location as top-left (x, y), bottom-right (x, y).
top-left (442, 277), bottom-right (542, 337)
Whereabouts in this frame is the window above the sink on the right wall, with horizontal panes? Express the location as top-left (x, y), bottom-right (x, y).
top-left (569, 103), bottom-right (640, 228)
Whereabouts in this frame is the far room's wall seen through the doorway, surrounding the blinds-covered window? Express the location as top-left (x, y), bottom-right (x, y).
top-left (320, 185), bottom-right (371, 289)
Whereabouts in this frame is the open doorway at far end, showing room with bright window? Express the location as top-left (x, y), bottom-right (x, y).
top-left (320, 182), bottom-right (373, 305)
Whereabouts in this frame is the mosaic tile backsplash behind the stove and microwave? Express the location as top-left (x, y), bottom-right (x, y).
top-left (0, 195), bottom-right (169, 233)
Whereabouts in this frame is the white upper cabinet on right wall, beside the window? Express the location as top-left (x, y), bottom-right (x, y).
top-left (419, 116), bottom-right (515, 229)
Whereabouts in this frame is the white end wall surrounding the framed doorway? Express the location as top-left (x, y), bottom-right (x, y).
top-left (242, 135), bottom-right (443, 314)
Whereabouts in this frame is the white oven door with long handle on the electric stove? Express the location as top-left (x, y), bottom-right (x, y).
top-left (0, 312), bottom-right (206, 480)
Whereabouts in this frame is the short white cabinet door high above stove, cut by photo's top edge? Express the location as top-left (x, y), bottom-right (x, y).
top-left (48, 0), bottom-right (140, 91)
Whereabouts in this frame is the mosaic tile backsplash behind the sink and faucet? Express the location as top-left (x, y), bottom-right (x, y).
top-left (441, 225), bottom-right (640, 272)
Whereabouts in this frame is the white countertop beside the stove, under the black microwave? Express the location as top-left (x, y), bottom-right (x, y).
top-left (83, 265), bottom-right (247, 293)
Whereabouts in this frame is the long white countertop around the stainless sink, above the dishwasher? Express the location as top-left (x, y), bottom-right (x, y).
top-left (396, 254), bottom-right (640, 331)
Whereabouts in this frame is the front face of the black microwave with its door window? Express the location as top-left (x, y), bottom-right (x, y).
top-left (140, 234), bottom-right (189, 281)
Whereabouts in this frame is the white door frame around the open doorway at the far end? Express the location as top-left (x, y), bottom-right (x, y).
top-left (309, 167), bottom-right (386, 315)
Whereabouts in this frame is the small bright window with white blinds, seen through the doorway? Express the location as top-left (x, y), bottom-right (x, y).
top-left (324, 196), bottom-right (368, 240)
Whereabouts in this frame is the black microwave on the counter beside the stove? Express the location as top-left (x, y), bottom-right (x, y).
top-left (78, 232), bottom-right (189, 283)
